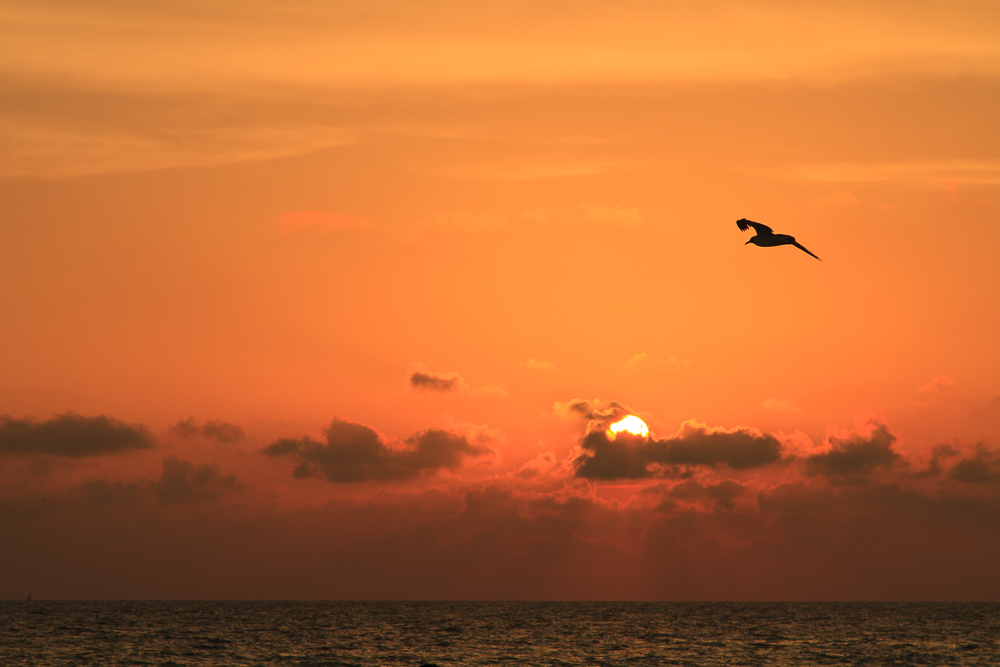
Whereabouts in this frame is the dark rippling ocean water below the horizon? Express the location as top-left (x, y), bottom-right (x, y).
top-left (0, 601), bottom-right (1000, 667)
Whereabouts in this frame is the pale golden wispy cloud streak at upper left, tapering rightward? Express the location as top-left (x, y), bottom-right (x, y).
top-left (0, 88), bottom-right (359, 178)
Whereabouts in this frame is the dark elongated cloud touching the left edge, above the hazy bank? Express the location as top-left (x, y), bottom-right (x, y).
top-left (0, 412), bottom-right (153, 457)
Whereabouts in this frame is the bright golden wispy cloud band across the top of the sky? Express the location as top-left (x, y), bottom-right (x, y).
top-left (0, 0), bottom-right (1000, 89)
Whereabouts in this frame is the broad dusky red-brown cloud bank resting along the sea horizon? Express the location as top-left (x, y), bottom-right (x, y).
top-left (0, 413), bottom-right (1000, 600)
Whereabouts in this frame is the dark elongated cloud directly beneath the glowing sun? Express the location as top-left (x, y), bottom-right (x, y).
top-left (576, 420), bottom-right (782, 480)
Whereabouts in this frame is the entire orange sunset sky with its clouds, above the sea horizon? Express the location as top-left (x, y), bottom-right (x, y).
top-left (0, 0), bottom-right (1000, 600)
